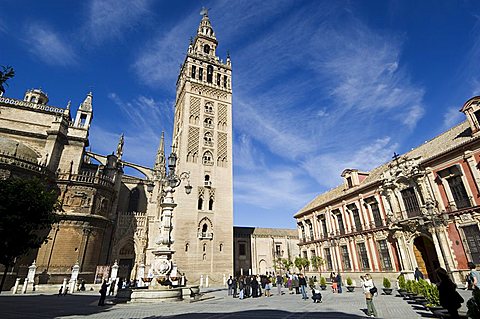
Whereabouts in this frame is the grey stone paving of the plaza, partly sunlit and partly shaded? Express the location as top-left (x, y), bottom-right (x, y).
top-left (0, 289), bottom-right (471, 319)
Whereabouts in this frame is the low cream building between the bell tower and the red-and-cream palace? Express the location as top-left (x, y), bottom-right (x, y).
top-left (233, 227), bottom-right (299, 276)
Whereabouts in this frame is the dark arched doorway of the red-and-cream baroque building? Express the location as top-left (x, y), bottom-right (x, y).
top-left (413, 236), bottom-right (440, 282)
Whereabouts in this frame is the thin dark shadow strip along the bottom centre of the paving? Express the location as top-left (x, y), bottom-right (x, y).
top-left (142, 310), bottom-right (365, 319)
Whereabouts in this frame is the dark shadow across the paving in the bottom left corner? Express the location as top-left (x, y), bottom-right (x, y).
top-left (0, 294), bottom-right (113, 319)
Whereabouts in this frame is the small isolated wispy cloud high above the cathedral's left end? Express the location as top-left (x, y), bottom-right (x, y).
top-left (24, 23), bottom-right (78, 66)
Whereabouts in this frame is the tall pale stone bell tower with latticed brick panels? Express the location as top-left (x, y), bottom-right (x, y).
top-left (172, 9), bottom-right (233, 284)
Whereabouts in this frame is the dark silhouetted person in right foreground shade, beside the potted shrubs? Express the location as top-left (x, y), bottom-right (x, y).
top-left (437, 268), bottom-right (464, 319)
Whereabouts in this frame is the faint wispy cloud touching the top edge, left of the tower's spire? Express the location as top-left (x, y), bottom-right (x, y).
top-left (84, 0), bottom-right (151, 43)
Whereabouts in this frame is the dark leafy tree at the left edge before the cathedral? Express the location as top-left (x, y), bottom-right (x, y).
top-left (0, 178), bottom-right (58, 292)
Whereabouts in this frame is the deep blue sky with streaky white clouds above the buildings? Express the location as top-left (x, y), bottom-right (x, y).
top-left (0, 0), bottom-right (480, 228)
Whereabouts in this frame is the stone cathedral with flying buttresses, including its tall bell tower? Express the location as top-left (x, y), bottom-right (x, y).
top-left (0, 10), bottom-right (233, 288)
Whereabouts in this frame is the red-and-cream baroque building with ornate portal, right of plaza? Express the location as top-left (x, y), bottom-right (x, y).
top-left (295, 96), bottom-right (480, 283)
